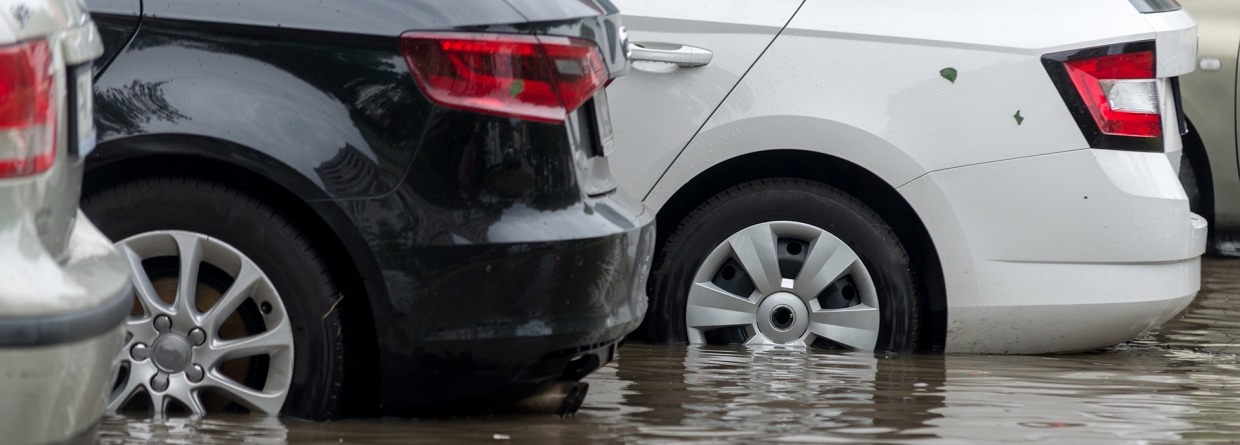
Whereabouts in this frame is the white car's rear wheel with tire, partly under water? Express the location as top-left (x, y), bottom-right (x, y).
top-left (645, 178), bottom-right (920, 352)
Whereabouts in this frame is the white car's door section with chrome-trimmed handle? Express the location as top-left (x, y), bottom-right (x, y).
top-left (608, 0), bottom-right (802, 197)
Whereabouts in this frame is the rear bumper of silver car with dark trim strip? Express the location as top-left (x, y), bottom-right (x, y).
top-left (0, 213), bottom-right (133, 444)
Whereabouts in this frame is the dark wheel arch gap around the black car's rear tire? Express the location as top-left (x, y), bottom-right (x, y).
top-left (82, 134), bottom-right (384, 414)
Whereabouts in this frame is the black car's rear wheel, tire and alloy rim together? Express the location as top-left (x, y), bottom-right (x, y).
top-left (82, 177), bottom-right (345, 419)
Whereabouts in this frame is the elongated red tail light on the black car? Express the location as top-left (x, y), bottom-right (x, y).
top-left (401, 31), bottom-right (608, 123)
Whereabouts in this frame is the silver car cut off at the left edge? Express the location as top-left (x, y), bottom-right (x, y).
top-left (0, 0), bottom-right (131, 444)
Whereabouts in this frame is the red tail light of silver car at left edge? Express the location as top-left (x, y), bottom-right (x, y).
top-left (0, 40), bottom-right (56, 178)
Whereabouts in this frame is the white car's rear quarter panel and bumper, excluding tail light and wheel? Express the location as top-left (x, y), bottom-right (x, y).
top-left (609, 0), bottom-right (1205, 353)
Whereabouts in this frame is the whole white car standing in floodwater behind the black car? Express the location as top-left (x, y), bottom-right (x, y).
top-left (609, 0), bottom-right (1205, 353)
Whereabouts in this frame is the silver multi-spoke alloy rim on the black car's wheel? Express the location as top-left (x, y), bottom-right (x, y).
top-left (108, 231), bottom-right (293, 414)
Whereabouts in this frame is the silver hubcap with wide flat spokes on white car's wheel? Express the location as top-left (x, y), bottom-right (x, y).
top-left (686, 221), bottom-right (879, 350)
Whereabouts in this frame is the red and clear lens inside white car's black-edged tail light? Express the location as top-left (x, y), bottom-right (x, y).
top-left (1064, 51), bottom-right (1162, 138)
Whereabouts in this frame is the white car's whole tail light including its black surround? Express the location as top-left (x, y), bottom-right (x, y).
top-left (1042, 41), bottom-right (1163, 151)
